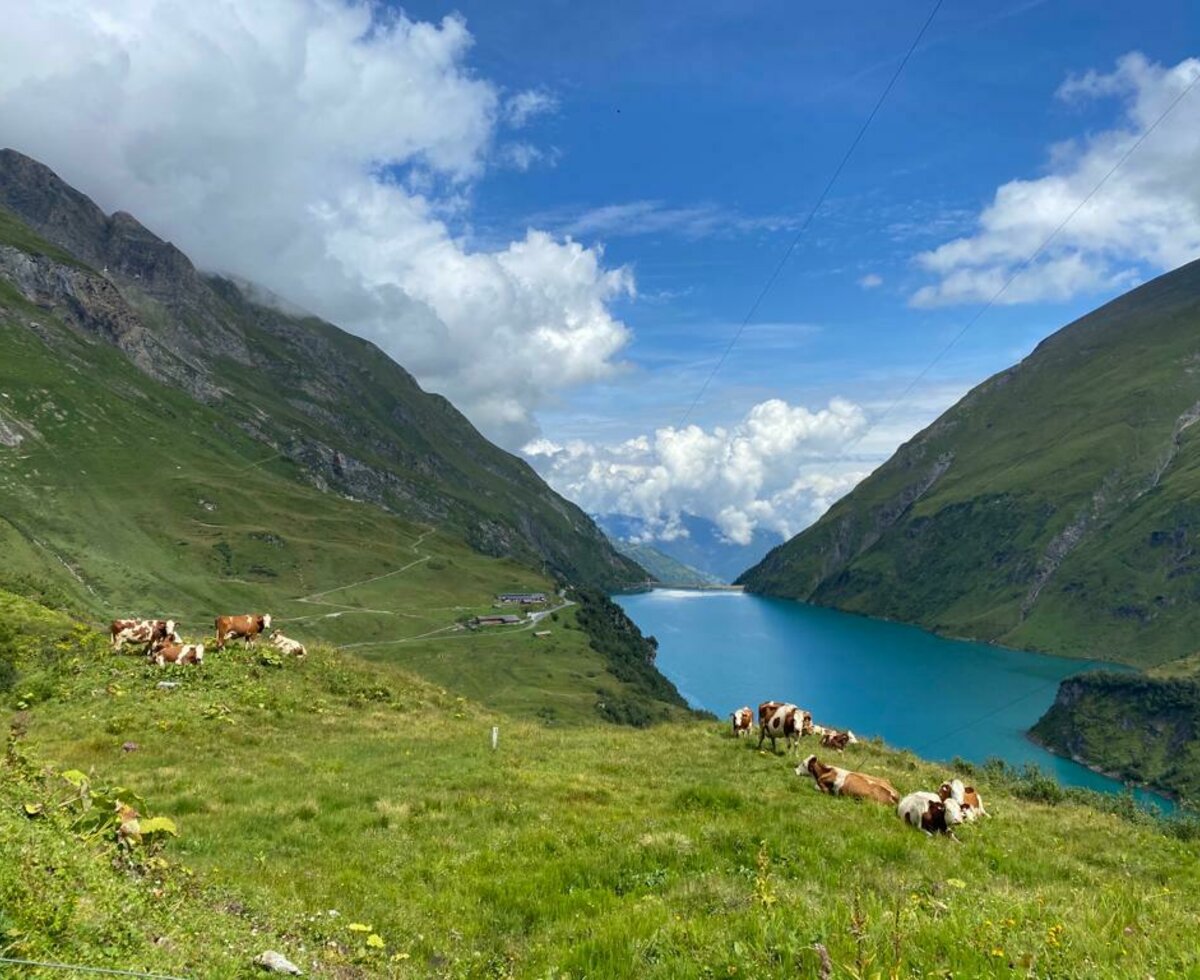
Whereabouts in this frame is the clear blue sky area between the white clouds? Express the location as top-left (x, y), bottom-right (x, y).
top-left (427, 0), bottom-right (1200, 438)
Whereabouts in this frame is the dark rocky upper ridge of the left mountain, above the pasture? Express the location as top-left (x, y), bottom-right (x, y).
top-left (0, 150), bottom-right (644, 587)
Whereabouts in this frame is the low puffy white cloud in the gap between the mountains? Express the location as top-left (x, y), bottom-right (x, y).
top-left (523, 398), bottom-right (866, 545)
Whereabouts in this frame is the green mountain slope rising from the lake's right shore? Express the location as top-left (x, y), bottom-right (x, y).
top-left (739, 263), bottom-right (1200, 665)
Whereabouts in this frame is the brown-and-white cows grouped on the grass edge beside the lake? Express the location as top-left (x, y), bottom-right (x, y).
top-left (731, 701), bottom-right (989, 840)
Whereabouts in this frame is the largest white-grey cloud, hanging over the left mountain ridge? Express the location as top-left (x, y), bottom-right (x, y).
top-left (0, 0), bottom-right (634, 445)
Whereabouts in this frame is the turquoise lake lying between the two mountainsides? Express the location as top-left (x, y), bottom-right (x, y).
top-left (614, 589), bottom-right (1170, 808)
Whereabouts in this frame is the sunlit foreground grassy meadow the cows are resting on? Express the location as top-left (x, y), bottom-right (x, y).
top-left (7, 599), bottom-right (1200, 978)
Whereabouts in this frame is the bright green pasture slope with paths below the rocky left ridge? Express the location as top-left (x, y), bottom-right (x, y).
top-left (0, 271), bottom-right (682, 721)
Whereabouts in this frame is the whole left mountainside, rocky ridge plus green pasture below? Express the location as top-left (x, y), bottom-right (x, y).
top-left (0, 151), bottom-right (683, 725)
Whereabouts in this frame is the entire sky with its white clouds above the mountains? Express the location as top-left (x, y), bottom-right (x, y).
top-left (0, 0), bottom-right (1200, 542)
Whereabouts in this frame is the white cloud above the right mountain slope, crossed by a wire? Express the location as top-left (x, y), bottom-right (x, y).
top-left (911, 53), bottom-right (1200, 307)
